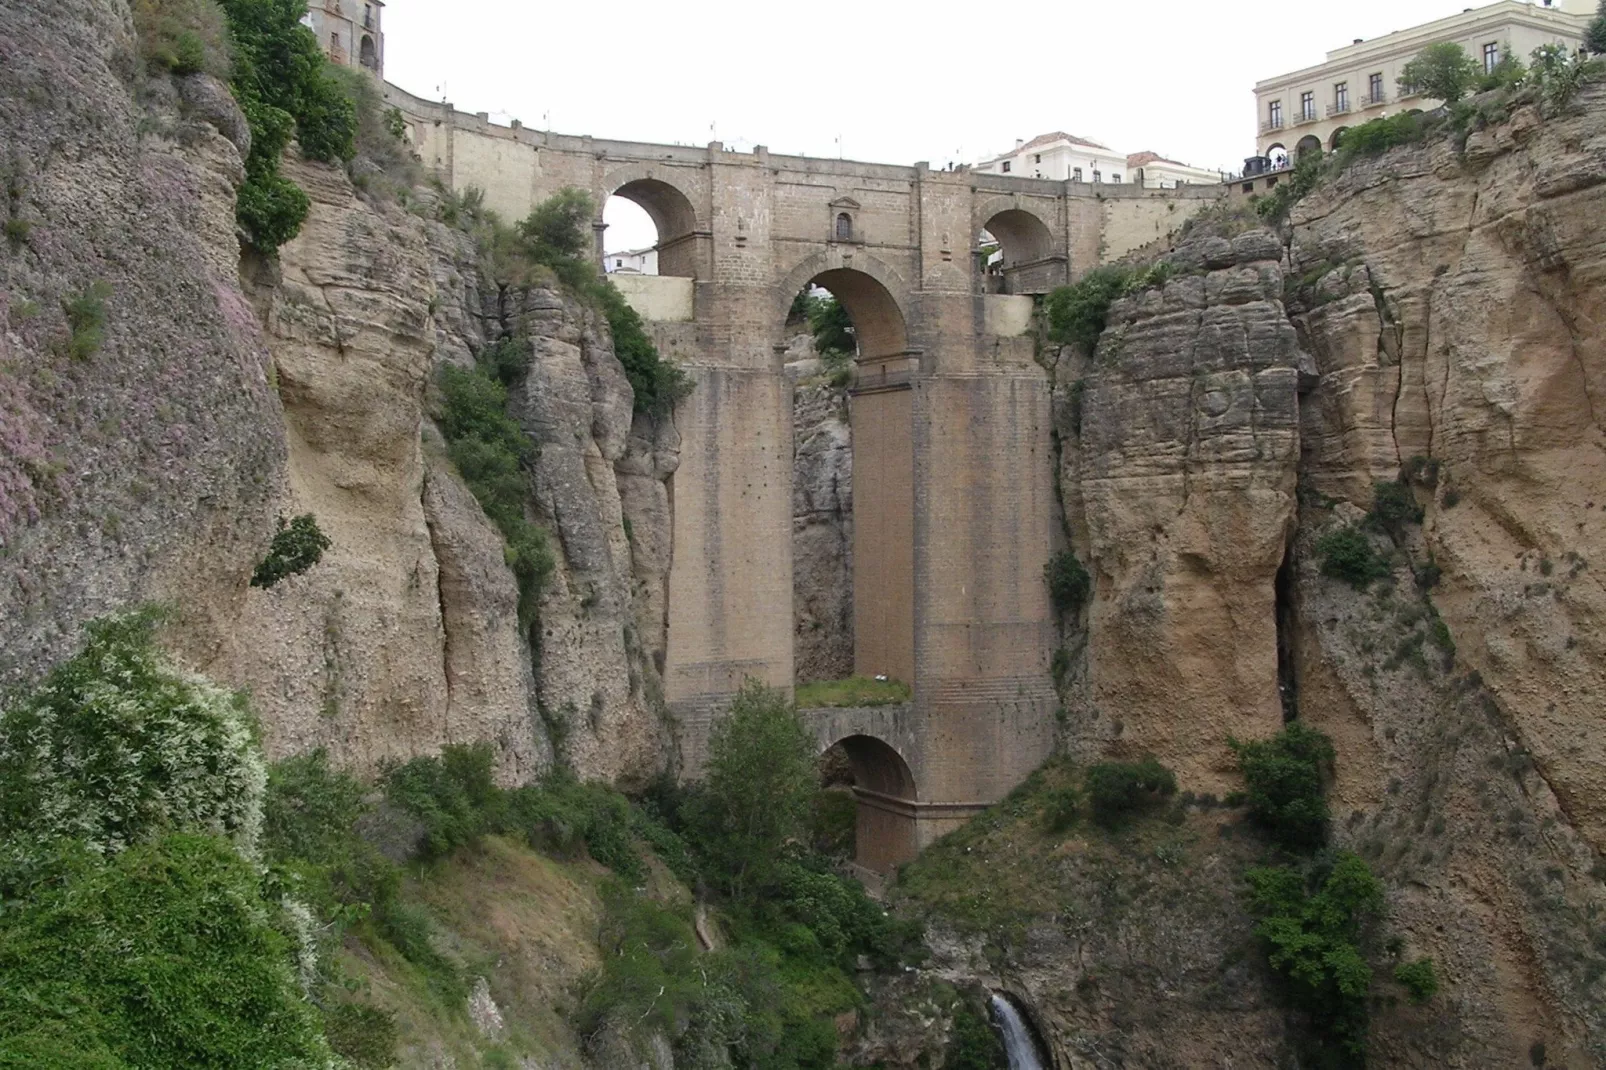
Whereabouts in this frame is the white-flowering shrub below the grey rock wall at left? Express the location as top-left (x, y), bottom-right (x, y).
top-left (0, 611), bottom-right (267, 861)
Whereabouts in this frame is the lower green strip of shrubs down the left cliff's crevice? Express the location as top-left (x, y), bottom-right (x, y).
top-left (435, 359), bottom-right (556, 628)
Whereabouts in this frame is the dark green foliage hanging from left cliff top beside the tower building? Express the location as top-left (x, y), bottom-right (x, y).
top-left (220, 0), bottom-right (357, 254)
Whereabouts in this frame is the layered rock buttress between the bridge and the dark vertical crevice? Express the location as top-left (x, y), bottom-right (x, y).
top-left (1055, 230), bottom-right (1301, 792)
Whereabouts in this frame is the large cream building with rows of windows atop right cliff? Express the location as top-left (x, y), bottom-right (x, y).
top-left (1254, 0), bottom-right (1595, 164)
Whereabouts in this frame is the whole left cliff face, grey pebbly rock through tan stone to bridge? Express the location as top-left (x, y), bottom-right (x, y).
top-left (0, 0), bottom-right (678, 782)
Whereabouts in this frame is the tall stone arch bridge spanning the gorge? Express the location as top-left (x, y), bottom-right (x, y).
top-left (387, 87), bottom-right (1221, 869)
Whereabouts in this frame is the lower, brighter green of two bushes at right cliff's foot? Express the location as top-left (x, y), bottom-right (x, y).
top-left (1245, 852), bottom-right (1383, 1067)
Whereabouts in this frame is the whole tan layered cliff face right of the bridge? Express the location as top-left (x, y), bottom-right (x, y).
top-left (1040, 87), bottom-right (1606, 1067)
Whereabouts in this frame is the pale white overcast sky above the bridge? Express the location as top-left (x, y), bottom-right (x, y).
top-left (384, 0), bottom-right (1466, 251)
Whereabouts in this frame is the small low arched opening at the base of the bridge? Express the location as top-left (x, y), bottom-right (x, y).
top-left (821, 736), bottom-right (919, 874)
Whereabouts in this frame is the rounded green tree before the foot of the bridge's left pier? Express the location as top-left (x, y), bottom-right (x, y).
top-left (697, 680), bottom-right (816, 898)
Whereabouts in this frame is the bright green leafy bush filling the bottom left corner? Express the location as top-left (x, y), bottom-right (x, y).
top-left (0, 832), bottom-right (329, 1070)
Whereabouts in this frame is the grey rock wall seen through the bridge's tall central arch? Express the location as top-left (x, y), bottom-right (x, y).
top-left (787, 334), bottom-right (853, 683)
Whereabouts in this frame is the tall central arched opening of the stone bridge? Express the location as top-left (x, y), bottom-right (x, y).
top-left (785, 262), bottom-right (915, 684)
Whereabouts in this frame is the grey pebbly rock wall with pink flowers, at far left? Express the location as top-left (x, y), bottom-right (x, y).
top-left (0, 0), bottom-right (286, 686)
